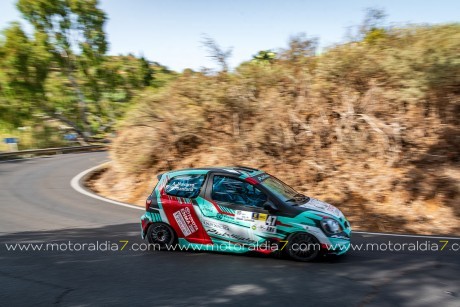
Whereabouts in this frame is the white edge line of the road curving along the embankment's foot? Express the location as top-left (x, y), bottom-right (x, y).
top-left (70, 162), bottom-right (460, 240)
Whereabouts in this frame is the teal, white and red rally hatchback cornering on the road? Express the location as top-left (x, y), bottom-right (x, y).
top-left (141, 166), bottom-right (351, 261)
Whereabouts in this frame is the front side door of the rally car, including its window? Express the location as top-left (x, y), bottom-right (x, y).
top-left (197, 174), bottom-right (277, 245)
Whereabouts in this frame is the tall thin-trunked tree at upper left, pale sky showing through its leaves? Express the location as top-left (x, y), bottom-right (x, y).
top-left (17, 0), bottom-right (107, 137)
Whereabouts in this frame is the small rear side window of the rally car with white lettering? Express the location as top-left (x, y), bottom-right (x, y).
top-left (165, 174), bottom-right (205, 198)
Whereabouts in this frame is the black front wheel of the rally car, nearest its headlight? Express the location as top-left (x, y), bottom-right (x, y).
top-left (286, 232), bottom-right (321, 262)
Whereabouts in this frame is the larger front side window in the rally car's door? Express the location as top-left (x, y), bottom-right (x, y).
top-left (211, 176), bottom-right (267, 207)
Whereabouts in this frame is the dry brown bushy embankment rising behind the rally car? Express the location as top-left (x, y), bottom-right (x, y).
top-left (91, 25), bottom-right (460, 235)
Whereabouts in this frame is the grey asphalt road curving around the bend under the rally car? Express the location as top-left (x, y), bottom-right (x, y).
top-left (0, 152), bottom-right (460, 306)
